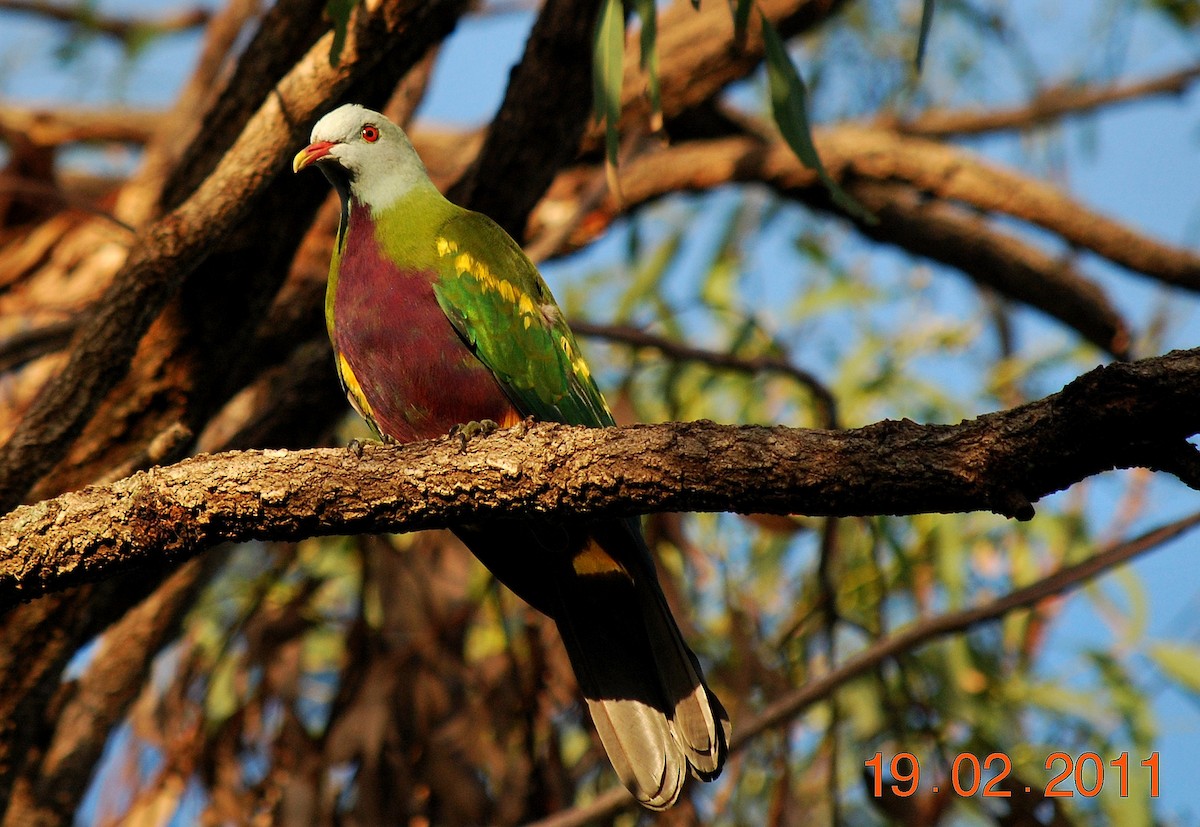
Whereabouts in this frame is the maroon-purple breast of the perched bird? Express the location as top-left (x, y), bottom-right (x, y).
top-left (332, 206), bottom-right (518, 442)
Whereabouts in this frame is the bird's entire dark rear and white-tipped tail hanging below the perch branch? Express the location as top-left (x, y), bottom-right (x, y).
top-left (455, 521), bottom-right (730, 810)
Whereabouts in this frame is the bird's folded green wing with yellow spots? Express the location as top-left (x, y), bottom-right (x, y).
top-left (433, 210), bottom-right (614, 426)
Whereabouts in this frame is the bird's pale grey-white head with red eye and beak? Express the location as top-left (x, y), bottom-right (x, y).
top-left (292, 103), bottom-right (436, 211)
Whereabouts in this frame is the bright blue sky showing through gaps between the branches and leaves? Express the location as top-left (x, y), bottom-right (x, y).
top-left (0, 0), bottom-right (1200, 820)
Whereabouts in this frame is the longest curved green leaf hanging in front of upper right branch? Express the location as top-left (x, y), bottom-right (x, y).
top-left (762, 16), bottom-right (878, 224)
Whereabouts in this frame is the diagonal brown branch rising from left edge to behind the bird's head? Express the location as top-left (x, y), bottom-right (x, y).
top-left (0, 2), bottom-right (468, 508)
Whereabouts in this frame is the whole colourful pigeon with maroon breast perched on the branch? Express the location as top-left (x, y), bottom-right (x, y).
top-left (292, 104), bottom-right (730, 809)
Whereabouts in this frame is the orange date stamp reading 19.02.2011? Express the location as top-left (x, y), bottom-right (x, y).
top-left (866, 753), bottom-right (1158, 798)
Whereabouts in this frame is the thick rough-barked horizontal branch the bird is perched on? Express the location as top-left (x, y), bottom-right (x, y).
top-left (0, 349), bottom-right (1200, 605)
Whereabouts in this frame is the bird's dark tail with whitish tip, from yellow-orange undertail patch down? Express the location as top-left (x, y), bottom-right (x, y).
top-left (553, 531), bottom-right (730, 809)
